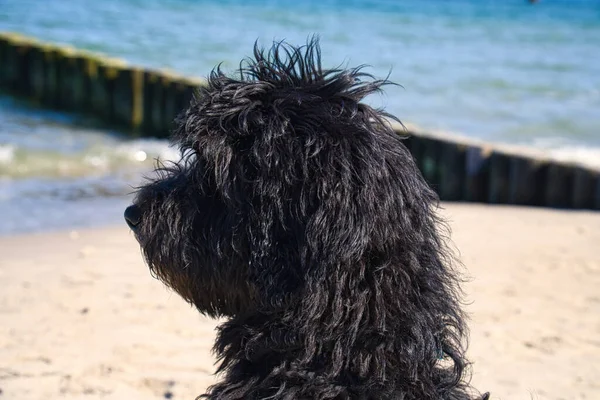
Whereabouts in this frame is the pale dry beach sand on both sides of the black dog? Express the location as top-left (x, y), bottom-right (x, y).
top-left (0, 204), bottom-right (600, 400)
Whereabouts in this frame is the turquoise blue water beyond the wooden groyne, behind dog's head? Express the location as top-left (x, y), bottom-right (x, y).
top-left (0, 0), bottom-right (600, 146)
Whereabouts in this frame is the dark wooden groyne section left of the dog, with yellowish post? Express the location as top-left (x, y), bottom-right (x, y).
top-left (0, 32), bottom-right (202, 137)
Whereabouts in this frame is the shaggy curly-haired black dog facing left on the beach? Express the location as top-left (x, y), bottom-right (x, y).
top-left (125, 40), bottom-right (487, 400)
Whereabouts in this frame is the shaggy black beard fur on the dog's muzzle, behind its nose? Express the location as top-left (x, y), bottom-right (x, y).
top-left (135, 169), bottom-right (255, 317)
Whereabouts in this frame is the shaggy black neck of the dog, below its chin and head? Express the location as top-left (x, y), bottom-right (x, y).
top-left (202, 314), bottom-right (472, 400)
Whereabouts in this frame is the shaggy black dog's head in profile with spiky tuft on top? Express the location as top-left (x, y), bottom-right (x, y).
top-left (126, 40), bottom-right (436, 316)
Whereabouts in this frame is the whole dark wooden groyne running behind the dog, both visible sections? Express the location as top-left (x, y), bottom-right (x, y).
top-left (0, 32), bottom-right (600, 210)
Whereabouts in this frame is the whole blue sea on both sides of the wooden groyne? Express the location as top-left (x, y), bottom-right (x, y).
top-left (0, 0), bottom-right (600, 235)
